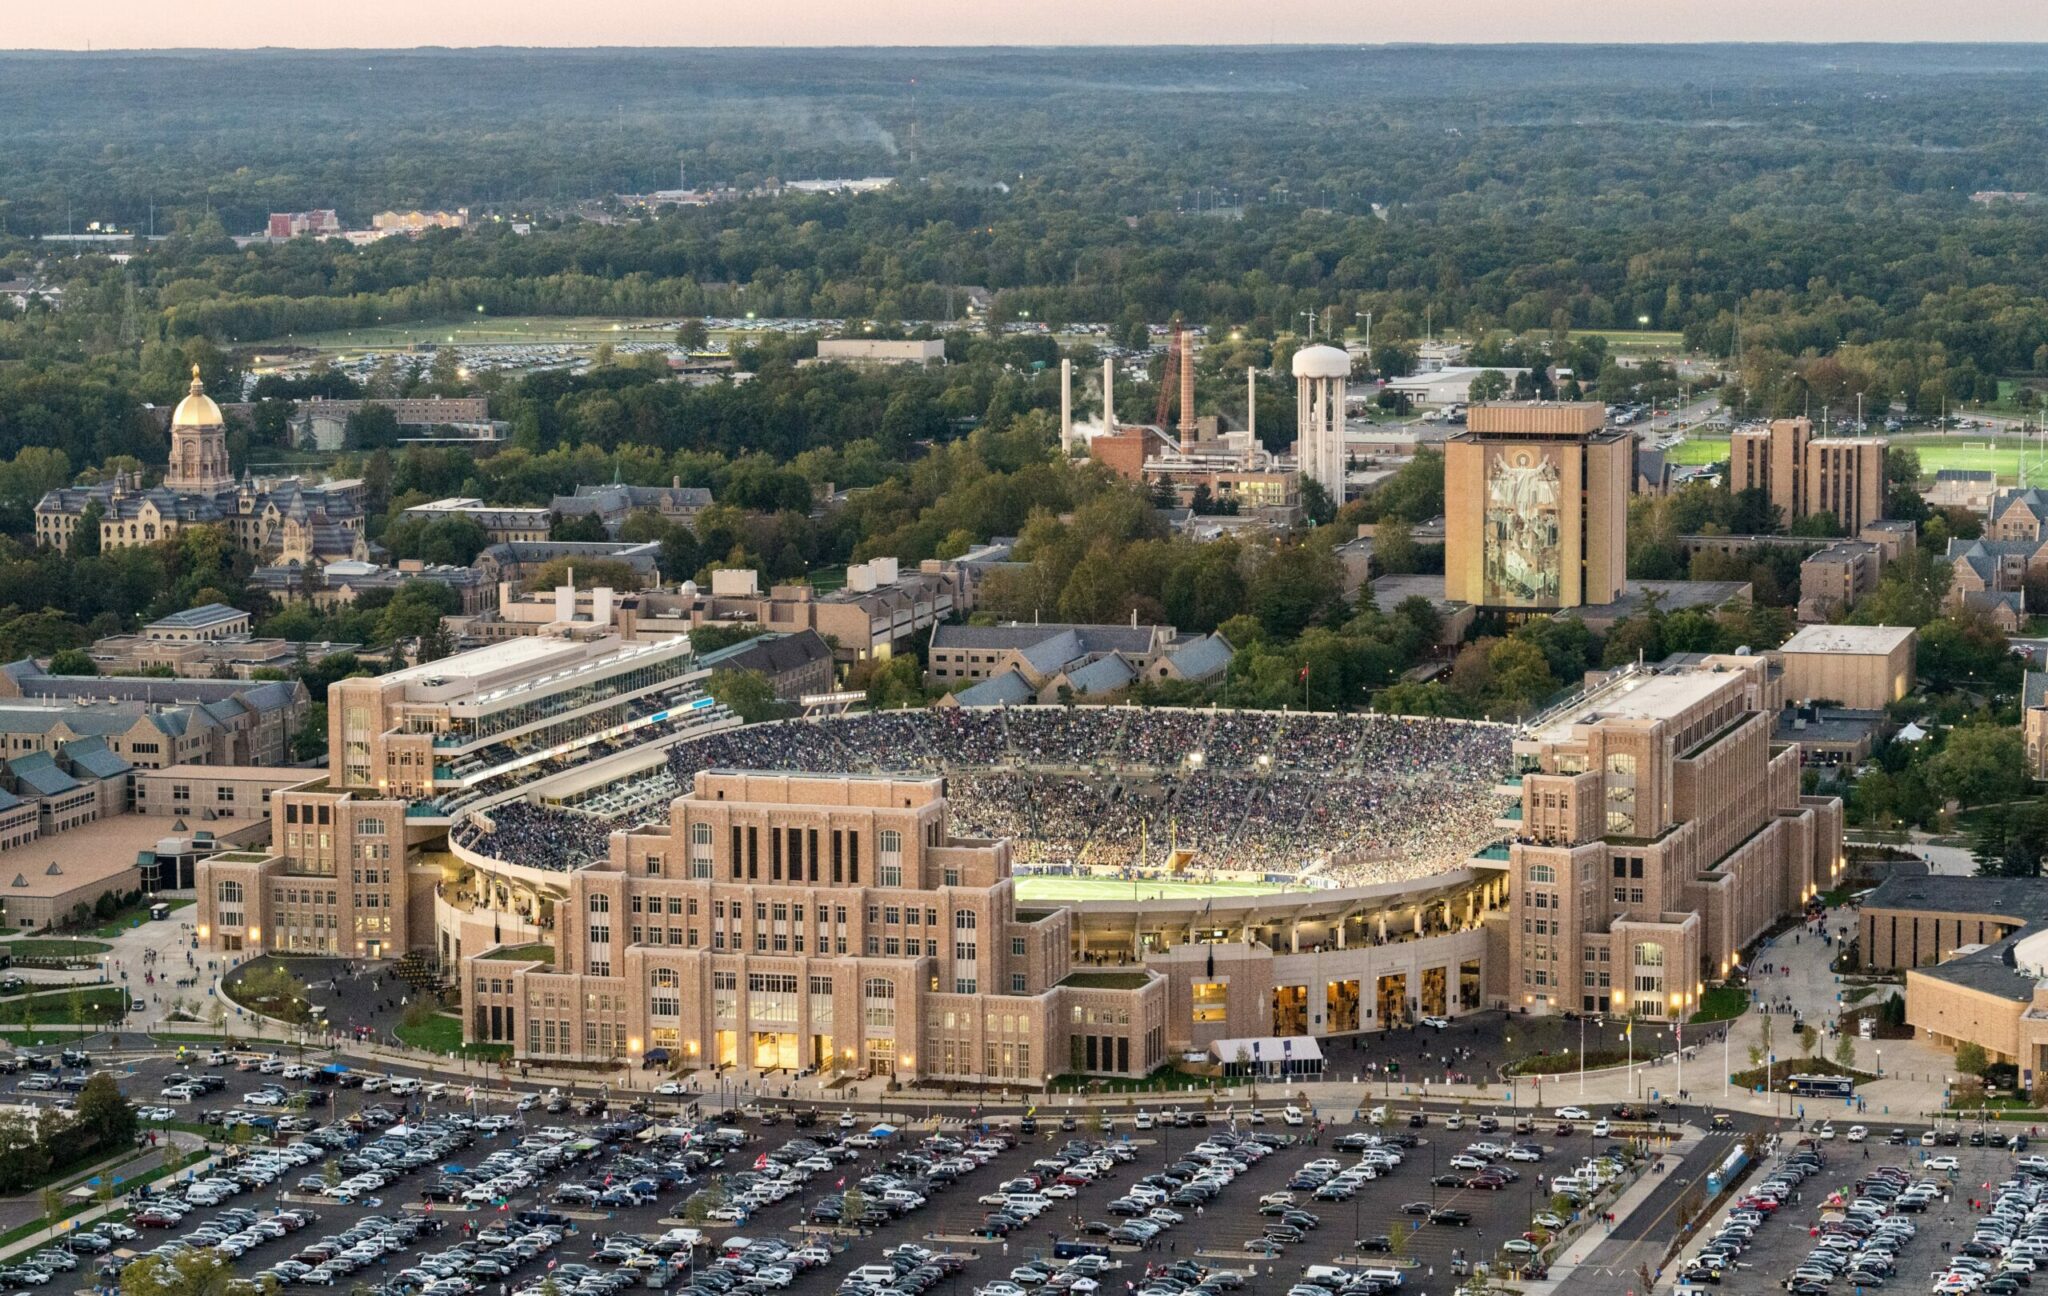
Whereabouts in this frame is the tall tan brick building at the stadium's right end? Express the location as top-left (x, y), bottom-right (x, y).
top-left (1507, 655), bottom-right (1843, 1020)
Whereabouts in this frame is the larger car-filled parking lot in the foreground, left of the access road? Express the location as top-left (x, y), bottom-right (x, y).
top-left (0, 1035), bottom-right (1679, 1296)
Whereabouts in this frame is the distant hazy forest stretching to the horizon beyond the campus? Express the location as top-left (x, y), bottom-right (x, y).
top-left (0, 47), bottom-right (2048, 419)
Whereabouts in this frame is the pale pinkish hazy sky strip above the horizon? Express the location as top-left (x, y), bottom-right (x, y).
top-left (16, 0), bottom-right (2048, 49)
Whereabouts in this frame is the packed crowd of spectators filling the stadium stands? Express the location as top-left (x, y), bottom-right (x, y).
top-left (468, 706), bottom-right (1511, 884)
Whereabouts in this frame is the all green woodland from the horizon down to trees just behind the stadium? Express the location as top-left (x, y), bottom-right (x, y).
top-left (0, 45), bottom-right (2048, 737)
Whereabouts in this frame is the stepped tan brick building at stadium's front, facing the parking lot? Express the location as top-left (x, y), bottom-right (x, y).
top-left (463, 772), bottom-right (1165, 1085)
